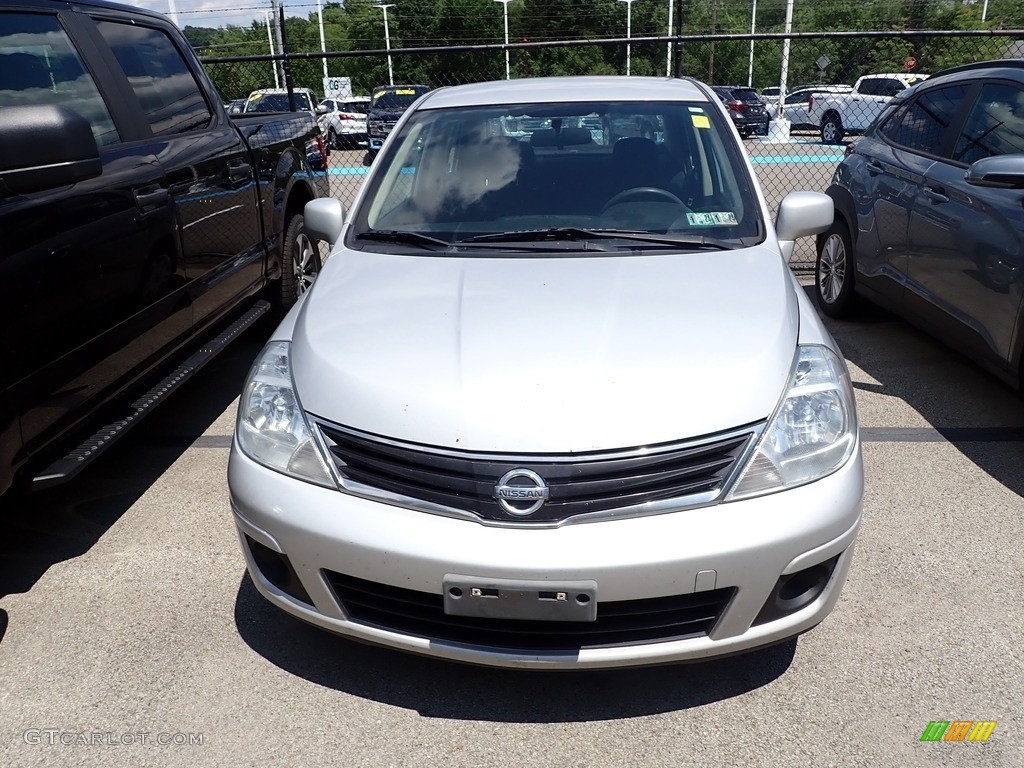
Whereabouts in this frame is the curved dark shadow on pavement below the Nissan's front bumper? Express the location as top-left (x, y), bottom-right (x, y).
top-left (234, 573), bottom-right (797, 723)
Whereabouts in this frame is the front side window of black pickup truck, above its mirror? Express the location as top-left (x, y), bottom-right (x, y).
top-left (0, 12), bottom-right (120, 146)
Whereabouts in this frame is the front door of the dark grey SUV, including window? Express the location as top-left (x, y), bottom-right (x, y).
top-left (909, 81), bottom-right (1024, 368)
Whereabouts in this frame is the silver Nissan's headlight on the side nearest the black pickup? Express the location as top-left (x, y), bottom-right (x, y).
top-left (234, 341), bottom-right (337, 488)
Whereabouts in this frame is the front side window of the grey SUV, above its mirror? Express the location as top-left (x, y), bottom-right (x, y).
top-left (953, 83), bottom-right (1024, 165)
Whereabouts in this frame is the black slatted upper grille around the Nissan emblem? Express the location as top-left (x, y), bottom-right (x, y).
top-left (318, 422), bottom-right (757, 523)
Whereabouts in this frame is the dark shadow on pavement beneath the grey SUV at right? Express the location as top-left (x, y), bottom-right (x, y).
top-left (806, 286), bottom-right (1024, 496)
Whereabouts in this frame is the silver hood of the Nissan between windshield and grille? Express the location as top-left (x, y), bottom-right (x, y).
top-left (292, 246), bottom-right (799, 453)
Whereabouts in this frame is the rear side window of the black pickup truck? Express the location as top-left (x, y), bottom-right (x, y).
top-left (96, 22), bottom-right (213, 136)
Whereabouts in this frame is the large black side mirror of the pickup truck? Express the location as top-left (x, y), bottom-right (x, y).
top-left (0, 104), bottom-right (103, 195)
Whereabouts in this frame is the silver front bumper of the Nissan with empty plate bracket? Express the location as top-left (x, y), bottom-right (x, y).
top-left (228, 446), bottom-right (863, 669)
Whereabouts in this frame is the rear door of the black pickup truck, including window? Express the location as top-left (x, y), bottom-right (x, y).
top-left (89, 13), bottom-right (265, 327)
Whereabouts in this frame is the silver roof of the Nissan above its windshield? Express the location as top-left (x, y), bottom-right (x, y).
top-left (420, 75), bottom-right (708, 110)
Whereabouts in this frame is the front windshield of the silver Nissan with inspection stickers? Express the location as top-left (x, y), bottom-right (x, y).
top-left (349, 101), bottom-right (764, 251)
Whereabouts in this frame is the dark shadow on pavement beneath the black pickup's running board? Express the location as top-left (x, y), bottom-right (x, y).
top-left (0, 324), bottom-right (271, 597)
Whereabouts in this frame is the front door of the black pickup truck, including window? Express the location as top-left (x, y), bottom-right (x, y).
top-left (0, 6), bottom-right (191, 457)
